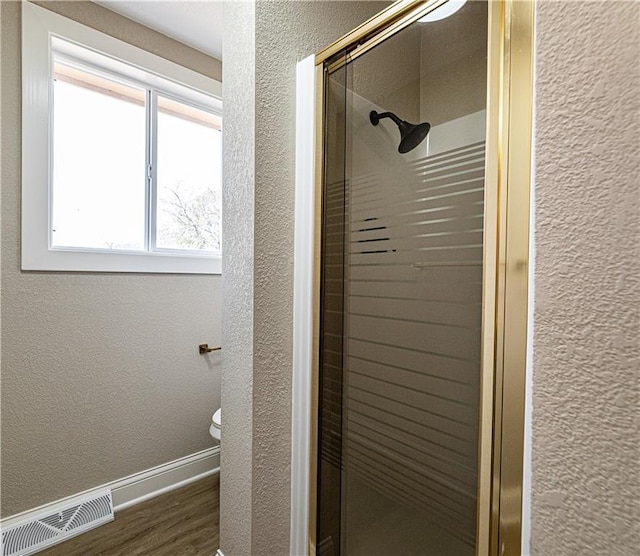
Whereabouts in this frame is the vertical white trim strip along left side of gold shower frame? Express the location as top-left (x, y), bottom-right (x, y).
top-left (290, 56), bottom-right (315, 556)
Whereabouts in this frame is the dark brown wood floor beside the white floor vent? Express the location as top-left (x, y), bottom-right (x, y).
top-left (38, 475), bottom-right (220, 556)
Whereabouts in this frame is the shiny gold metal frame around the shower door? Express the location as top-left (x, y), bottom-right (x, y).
top-left (309, 0), bottom-right (535, 556)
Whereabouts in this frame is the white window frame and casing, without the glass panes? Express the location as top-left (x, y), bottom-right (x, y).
top-left (22, 2), bottom-right (222, 274)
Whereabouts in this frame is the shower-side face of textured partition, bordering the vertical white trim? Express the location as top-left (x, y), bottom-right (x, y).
top-left (252, 0), bottom-right (386, 556)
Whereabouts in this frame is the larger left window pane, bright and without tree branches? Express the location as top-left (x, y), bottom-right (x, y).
top-left (51, 63), bottom-right (146, 250)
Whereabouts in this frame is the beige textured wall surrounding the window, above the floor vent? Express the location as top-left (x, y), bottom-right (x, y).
top-left (0, 2), bottom-right (221, 516)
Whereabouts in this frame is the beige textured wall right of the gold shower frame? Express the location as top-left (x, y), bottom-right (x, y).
top-left (531, 0), bottom-right (640, 556)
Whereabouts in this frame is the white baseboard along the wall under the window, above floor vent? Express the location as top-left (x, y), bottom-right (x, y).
top-left (0, 446), bottom-right (220, 528)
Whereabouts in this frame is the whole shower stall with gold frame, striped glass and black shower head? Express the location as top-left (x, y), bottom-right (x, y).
top-left (296, 0), bottom-right (531, 556)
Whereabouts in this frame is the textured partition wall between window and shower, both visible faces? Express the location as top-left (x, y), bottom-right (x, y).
top-left (220, 1), bottom-right (387, 556)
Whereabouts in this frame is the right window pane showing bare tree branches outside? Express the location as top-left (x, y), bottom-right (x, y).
top-left (156, 97), bottom-right (222, 253)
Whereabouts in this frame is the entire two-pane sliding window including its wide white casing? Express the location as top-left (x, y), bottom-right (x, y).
top-left (22, 3), bottom-right (222, 273)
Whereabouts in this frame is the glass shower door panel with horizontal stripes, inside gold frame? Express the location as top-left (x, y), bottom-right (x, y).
top-left (317, 2), bottom-right (487, 556)
